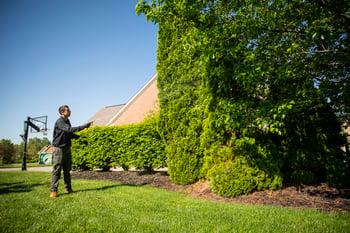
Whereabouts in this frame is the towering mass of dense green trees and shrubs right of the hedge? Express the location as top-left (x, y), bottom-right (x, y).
top-left (136, 0), bottom-right (350, 196)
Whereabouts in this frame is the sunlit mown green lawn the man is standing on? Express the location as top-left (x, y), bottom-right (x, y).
top-left (0, 171), bottom-right (350, 233)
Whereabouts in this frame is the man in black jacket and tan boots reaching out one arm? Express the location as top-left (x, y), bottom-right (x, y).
top-left (50, 105), bottom-right (91, 198)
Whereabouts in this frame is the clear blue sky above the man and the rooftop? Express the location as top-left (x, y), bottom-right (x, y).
top-left (0, 0), bottom-right (158, 144)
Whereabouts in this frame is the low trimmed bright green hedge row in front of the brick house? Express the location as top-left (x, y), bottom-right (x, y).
top-left (72, 117), bottom-right (166, 171)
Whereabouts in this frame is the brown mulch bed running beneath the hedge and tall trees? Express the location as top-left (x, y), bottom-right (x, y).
top-left (72, 171), bottom-right (350, 214)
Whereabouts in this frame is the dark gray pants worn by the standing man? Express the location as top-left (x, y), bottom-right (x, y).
top-left (50, 146), bottom-right (72, 192)
